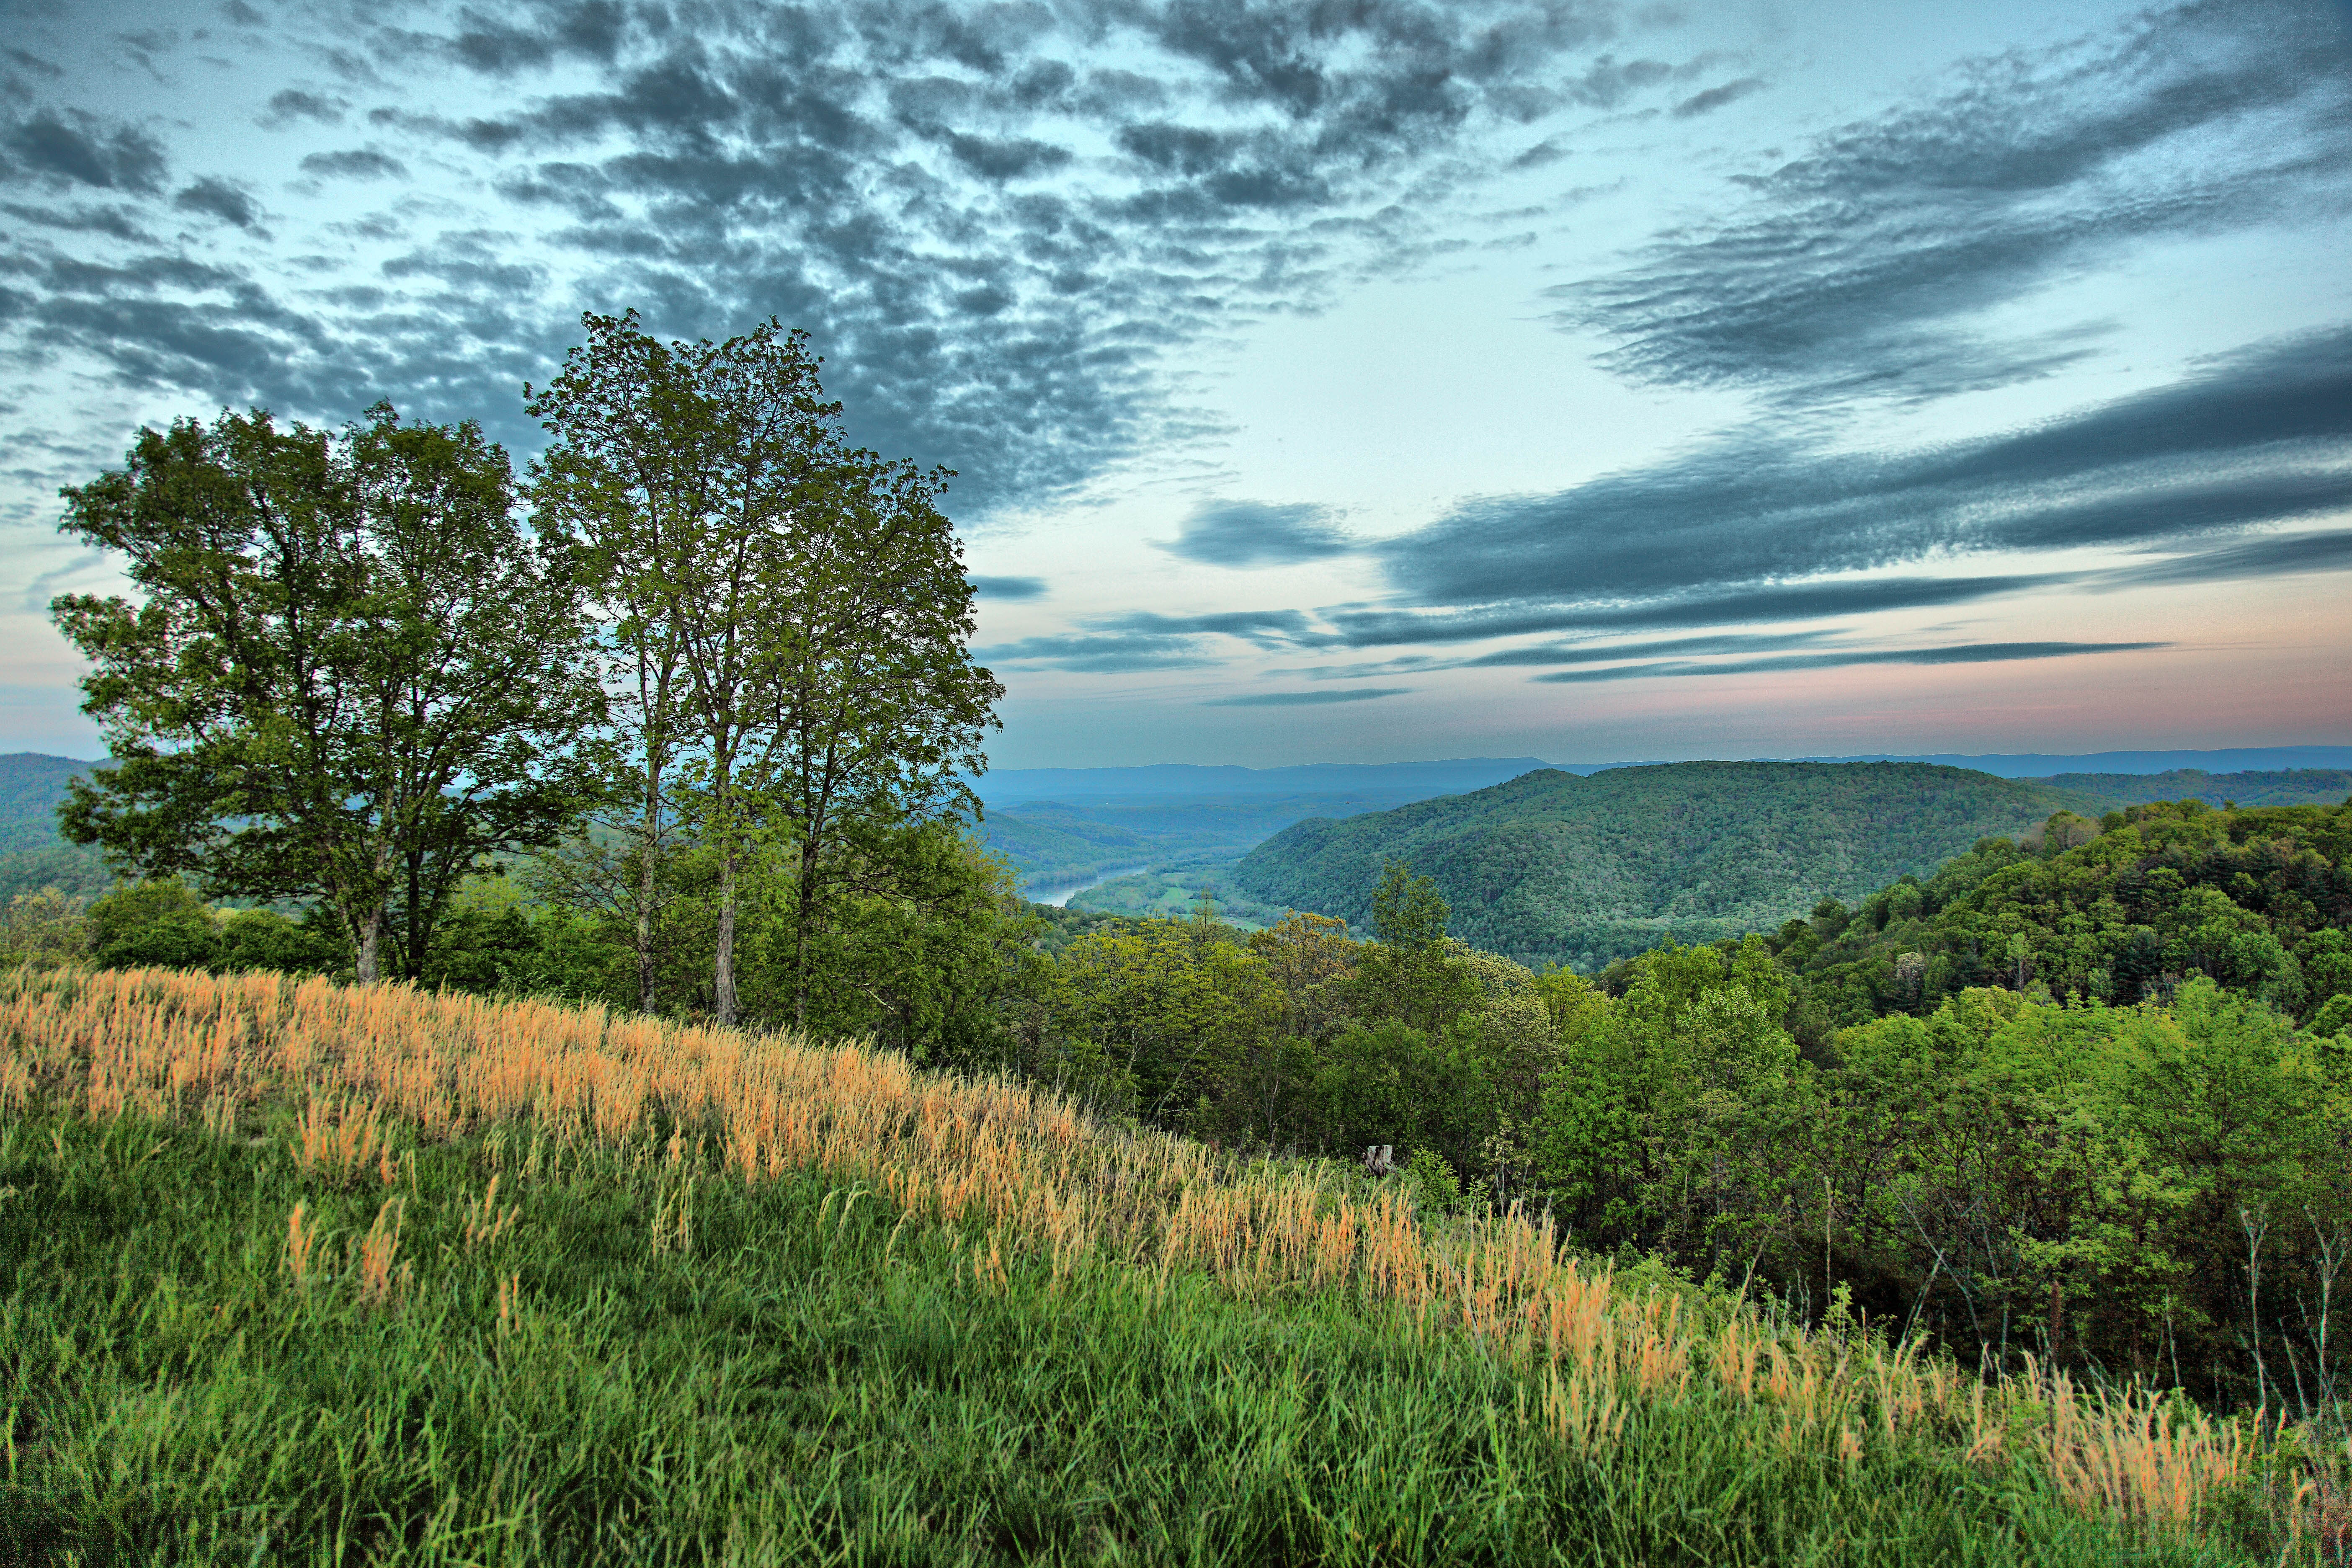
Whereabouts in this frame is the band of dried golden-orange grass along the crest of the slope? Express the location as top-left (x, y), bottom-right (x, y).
top-left (0, 971), bottom-right (2286, 1533)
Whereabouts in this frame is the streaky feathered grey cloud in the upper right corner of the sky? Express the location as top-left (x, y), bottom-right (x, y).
top-left (1553, 0), bottom-right (2352, 400)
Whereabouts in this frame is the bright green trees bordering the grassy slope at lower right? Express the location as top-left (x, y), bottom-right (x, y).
top-left (1536, 959), bottom-right (2352, 1411)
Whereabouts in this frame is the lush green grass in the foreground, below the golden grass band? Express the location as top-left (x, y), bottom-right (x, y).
top-left (0, 1114), bottom-right (2277, 1568)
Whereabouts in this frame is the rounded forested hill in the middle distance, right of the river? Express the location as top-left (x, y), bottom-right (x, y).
top-left (1235, 762), bottom-right (2091, 969)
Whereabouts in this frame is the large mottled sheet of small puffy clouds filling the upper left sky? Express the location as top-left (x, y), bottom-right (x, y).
top-left (0, 0), bottom-right (1731, 515)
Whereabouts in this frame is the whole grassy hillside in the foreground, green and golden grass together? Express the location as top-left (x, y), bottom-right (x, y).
top-left (0, 971), bottom-right (2340, 1568)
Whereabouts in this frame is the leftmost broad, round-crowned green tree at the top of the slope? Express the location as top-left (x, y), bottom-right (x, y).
top-left (49, 404), bottom-right (604, 985)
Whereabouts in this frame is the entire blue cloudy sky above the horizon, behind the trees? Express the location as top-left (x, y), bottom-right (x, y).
top-left (0, 0), bottom-right (2352, 766)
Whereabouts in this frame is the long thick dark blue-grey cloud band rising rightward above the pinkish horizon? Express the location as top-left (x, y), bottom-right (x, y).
top-left (1373, 327), bottom-right (2352, 611)
